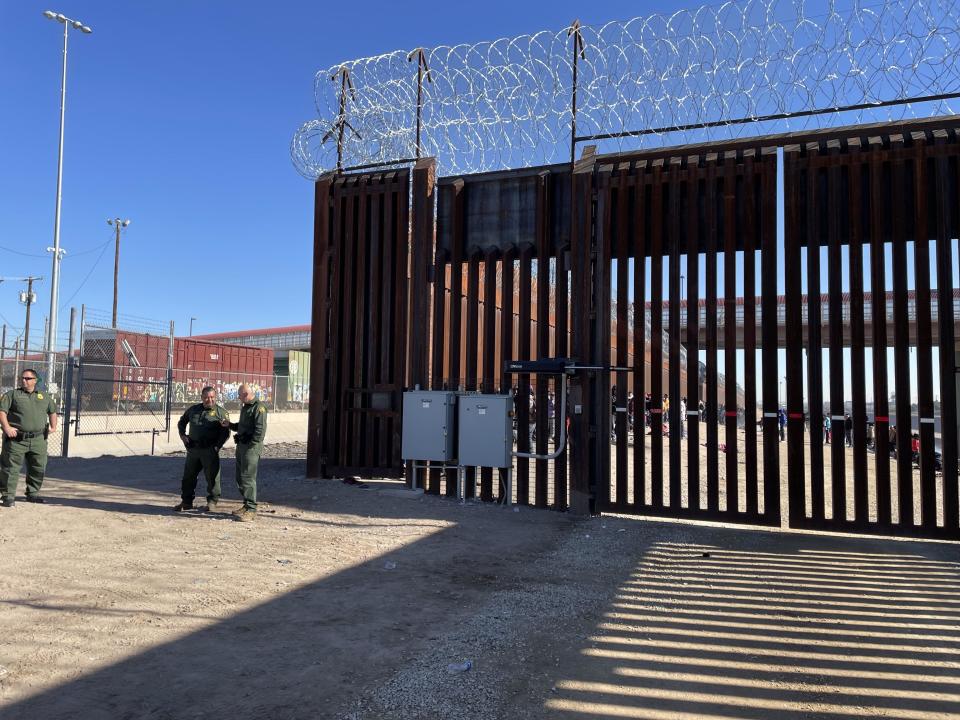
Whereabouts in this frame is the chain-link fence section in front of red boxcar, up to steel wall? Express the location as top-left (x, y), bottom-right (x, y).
top-left (68, 309), bottom-right (309, 457)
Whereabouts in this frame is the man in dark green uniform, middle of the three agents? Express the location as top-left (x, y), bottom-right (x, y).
top-left (173, 387), bottom-right (230, 512)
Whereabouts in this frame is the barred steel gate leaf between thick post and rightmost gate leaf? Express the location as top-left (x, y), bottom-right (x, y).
top-left (580, 146), bottom-right (780, 525)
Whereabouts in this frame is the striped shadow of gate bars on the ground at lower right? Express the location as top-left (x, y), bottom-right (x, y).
top-left (546, 532), bottom-right (960, 720)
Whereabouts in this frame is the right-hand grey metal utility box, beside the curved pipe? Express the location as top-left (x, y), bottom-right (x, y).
top-left (457, 395), bottom-right (513, 468)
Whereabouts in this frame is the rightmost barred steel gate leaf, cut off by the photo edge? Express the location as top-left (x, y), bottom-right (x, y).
top-left (785, 124), bottom-right (960, 538)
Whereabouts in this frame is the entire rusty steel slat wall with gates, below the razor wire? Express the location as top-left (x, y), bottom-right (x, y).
top-left (308, 119), bottom-right (960, 538)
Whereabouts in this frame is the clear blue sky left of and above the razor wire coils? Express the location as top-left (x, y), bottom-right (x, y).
top-left (0, 0), bottom-right (688, 345)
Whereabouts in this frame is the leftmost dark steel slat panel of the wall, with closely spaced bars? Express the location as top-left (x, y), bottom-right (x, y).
top-left (307, 164), bottom-right (410, 477)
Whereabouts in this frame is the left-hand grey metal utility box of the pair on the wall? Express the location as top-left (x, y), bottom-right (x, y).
top-left (400, 390), bottom-right (457, 462)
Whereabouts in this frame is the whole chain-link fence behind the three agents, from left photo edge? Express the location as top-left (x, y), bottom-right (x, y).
top-left (0, 309), bottom-right (310, 457)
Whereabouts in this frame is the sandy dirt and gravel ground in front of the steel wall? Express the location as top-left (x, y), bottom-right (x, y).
top-left (0, 447), bottom-right (960, 720)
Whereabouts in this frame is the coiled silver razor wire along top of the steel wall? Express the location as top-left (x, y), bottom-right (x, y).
top-left (291, 0), bottom-right (960, 178)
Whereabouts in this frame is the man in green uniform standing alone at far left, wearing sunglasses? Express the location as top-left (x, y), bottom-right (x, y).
top-left (0, 368), bottom-right (57, 507)
